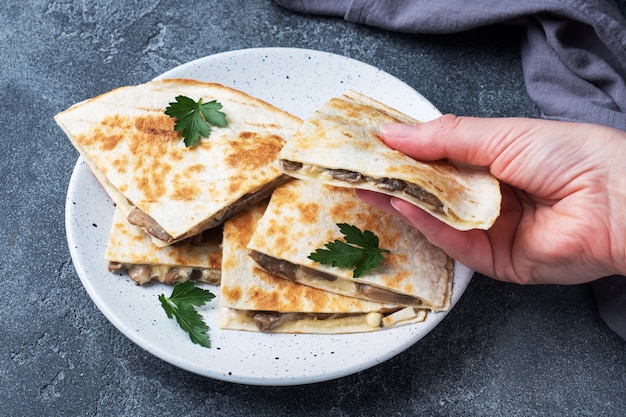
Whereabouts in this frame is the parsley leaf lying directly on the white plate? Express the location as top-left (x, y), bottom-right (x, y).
top-left (159, 281), bottom-right (215, 347)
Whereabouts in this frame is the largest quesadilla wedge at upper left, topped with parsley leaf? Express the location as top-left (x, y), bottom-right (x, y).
top-left (55, 79), bottom-right (301, 246)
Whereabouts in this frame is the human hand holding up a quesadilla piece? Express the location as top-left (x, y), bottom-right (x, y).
top-left (357, 115), bottom-right (626, 284)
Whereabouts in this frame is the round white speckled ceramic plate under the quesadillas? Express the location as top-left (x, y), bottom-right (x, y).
top-left (65, 48), bottom-right (472, 385)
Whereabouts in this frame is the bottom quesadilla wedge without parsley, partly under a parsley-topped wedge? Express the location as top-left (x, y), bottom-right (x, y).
top-left (218, 203), bottom-right (426, 334)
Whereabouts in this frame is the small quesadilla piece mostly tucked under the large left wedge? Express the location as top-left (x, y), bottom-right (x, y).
top-left (104, 209), bottom-right (222, 285)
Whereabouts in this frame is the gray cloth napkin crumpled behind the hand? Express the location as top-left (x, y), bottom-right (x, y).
top-left (274, 0), bottom-right (626, 339)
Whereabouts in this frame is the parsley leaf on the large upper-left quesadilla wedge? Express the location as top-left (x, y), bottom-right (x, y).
top-left (165, 96), bottom-right (226, 147)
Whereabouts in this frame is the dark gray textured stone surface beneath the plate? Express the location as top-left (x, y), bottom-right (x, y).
top-left (0, 0), bottom-right (626, 417)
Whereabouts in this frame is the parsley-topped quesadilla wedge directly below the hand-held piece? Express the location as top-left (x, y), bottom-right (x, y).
top-left (248, 180), bottom-right (454, 311)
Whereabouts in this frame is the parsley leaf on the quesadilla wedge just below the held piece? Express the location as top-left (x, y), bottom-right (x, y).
top-left (308, 223), bottom-right (389, 278)
